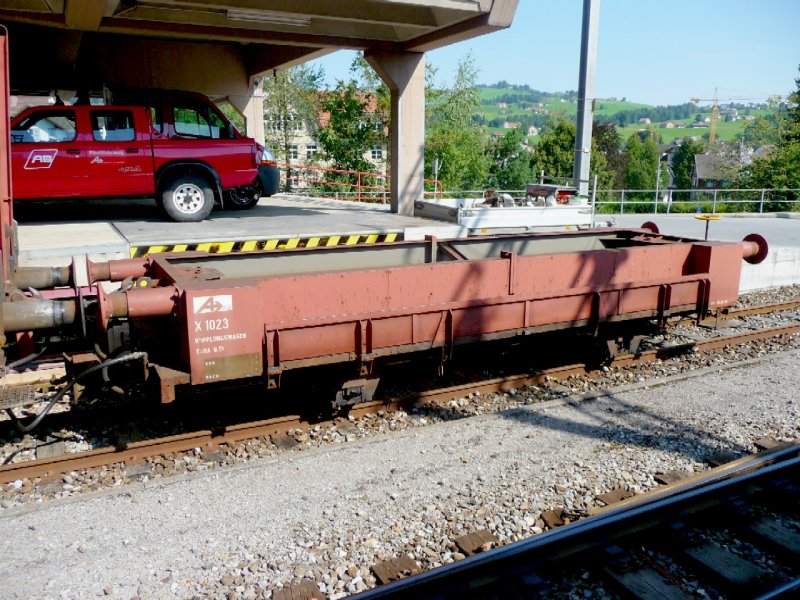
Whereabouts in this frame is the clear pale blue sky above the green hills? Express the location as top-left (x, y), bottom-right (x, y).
top-left (315, 0), bottom-right (800, 104)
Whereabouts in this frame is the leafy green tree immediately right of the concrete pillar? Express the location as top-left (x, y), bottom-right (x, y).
top-left (425, 54), bottom-right (489, 190)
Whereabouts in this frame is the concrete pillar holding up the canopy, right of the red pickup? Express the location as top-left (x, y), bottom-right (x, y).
top-left (364, 50), bottom-right (425, 215)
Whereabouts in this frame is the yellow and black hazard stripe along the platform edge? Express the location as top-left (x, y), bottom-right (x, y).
top-left (131, 233), bottom-right (402, 258)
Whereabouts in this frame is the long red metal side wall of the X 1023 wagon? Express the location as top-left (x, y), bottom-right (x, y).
top-left (175, 238), bottom-right (741, 381)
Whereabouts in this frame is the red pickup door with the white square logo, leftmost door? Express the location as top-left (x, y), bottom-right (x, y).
top-left (11, 107), bottom-right (86, 199)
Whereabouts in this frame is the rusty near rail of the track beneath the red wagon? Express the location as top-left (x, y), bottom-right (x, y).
top-left (0, 324), bottom-right (800, 483)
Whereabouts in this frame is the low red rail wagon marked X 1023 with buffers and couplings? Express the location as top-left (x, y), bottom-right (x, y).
top-left (0, 27), bottom-right (767, 422)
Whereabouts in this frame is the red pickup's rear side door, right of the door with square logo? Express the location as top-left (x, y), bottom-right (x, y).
top-left (86, 106), bottom-right (155, 196)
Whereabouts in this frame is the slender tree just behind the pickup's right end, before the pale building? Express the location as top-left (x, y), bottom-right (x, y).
top-left (264, 65), bottom-right (324, 189)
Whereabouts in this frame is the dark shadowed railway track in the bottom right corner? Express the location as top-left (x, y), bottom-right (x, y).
top-left (358, 444), bottom-right (800, 600)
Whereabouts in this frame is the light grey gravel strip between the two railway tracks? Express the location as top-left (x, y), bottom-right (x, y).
top-left (0, 350), bottom-right (800, 598)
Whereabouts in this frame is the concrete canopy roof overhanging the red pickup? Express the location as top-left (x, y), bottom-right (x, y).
top-left (0, 0), bottom-right (518, 95)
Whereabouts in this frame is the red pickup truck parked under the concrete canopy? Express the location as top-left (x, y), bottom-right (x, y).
top-left (11, 92), bottom-right (277, 221)
